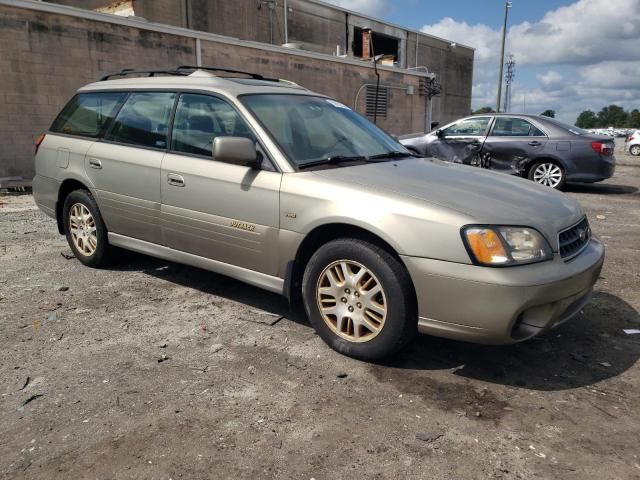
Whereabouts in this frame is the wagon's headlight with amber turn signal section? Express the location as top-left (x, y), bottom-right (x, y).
top-left (462, 225), bottom-right (553, 267)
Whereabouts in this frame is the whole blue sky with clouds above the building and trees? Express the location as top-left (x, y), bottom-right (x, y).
top-left (326, 0), bottom-right (640, 123)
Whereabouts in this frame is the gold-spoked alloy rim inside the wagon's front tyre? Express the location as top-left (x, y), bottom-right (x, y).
top-left (316, 260), bottom-right (387, 343)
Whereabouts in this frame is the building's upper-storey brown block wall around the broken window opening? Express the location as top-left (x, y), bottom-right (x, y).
top-left (47, 0), bottom-right (474, 124)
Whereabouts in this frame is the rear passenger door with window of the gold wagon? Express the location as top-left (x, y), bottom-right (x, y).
top-left (85, 92), bottom-right (176, 243)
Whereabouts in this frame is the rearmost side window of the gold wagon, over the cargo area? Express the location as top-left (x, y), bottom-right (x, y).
top-left (50, 92), bottom-right (127, 138)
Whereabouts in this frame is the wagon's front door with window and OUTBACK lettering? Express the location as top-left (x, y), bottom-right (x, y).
top-left (161, 93), bottom-right (282, 275)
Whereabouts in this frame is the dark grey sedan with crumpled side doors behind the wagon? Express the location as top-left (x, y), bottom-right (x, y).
top-left (400, 114), bottom-right (615, 189)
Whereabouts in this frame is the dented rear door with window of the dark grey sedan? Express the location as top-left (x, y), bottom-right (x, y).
top-left (481, 116), bottom-right (549, 175)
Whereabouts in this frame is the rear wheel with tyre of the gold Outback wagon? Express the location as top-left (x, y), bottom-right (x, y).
top-left (63, 190), bottom-right (113, 267)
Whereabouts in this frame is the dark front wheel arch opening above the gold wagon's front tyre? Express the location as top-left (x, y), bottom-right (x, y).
top-left (284, 222), bottom-right (417, 303)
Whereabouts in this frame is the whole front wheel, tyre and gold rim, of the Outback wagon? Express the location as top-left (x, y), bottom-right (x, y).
top-left (302, 238), bottom-right (417, 361)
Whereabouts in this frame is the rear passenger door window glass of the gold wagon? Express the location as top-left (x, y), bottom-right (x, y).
top-left (106, 92), bottom-right (176, 148)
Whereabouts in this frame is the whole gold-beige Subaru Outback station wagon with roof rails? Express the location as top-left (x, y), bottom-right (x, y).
top-left (33, 67), bottom-right (604, 360)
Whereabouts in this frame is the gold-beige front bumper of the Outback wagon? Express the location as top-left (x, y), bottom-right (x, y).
top-left (402, 238), bottom-right (604, 344)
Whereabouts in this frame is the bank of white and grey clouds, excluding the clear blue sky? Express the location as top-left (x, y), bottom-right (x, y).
top-left (422, 0), bottom-right (640, 121)
